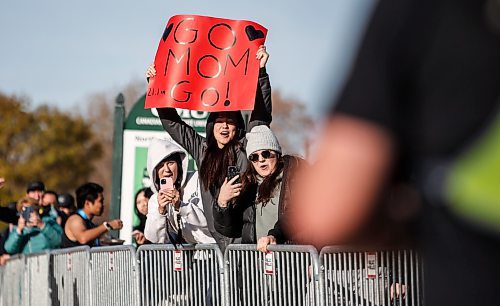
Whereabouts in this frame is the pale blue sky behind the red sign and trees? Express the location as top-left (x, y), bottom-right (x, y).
top-left (0, 0), bottom-right (376, 116)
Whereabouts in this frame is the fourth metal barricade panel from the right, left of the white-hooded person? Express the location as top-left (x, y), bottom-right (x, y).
top-left (90, 245), bottom-right (140, 306)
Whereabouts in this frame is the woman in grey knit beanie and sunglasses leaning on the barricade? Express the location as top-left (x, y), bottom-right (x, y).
top-left (214, 125), bottom-right (304, 252)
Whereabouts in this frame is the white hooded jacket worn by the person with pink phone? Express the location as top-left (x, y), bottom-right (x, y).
top-left (144, 138), bottom-right (215, 243)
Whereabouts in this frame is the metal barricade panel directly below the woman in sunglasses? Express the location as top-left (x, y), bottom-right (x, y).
top-left (224, 244), bottom-right (322, 306)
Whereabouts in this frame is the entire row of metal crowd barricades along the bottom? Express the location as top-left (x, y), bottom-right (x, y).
top-left (0, 244), bottom-right (423, 306)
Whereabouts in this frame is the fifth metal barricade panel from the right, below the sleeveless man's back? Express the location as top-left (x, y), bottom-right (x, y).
top-left (50, 246), bottom-right (90, 306)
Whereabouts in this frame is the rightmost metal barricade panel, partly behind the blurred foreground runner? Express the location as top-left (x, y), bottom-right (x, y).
top-left (320, 247), bottom-right (423, 306)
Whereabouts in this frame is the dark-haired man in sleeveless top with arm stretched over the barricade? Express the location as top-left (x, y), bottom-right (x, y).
top-left (61, 183), bottom-right (123, 248)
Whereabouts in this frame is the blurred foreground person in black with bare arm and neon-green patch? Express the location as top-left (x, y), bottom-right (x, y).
top-left (294, 0), bottom-right (500, 305)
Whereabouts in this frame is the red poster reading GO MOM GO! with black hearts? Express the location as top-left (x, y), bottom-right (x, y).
top-left (145, 15), bottom-right (267, 112)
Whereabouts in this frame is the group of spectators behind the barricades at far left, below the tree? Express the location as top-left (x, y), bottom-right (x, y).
top-left (0, 178), bottom-right (122, 264)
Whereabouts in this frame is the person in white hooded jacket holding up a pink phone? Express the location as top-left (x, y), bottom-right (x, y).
top-left (144, 138), bottom-right (215, 244)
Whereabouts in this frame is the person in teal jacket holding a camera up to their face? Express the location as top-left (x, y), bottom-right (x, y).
top-left (4, 197), bottom-right (62, 254)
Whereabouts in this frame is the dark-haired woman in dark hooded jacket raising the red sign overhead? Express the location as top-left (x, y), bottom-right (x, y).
top-left (146, 46), bottom-right (272, 251)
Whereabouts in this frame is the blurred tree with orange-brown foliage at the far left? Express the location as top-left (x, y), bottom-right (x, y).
top-left (0, 93), bottom-right (102, 200)
